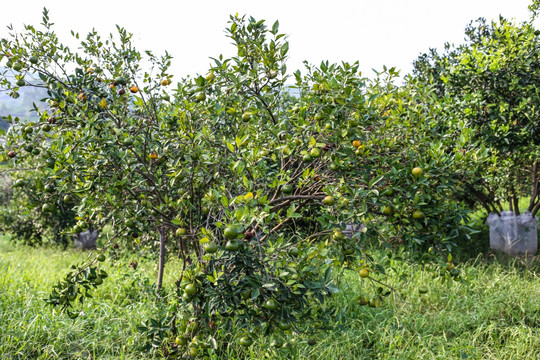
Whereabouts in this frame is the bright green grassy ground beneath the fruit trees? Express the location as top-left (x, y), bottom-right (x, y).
top-left (0, 239), bottom-right (540, 360)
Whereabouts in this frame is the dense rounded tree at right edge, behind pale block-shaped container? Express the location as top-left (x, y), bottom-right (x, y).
top-left (415, 17), bottom-right (540, 216)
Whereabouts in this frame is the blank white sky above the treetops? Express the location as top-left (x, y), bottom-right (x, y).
top-left (0, 0), bottom-right (530, 80)
